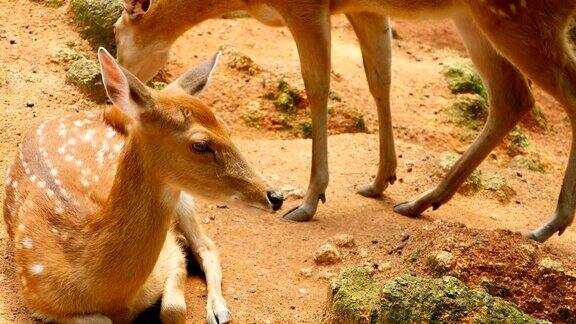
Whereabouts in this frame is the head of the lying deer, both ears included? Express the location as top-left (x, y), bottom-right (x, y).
top-left (98, 49), bottom-right (282, 210)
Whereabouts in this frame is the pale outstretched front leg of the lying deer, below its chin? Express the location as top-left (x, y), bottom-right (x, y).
top-left (176, 193), bottom-right (232, 324)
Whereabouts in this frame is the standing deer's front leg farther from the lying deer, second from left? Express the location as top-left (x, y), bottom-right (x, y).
top-left (347, 13), bottom-right (396, 197)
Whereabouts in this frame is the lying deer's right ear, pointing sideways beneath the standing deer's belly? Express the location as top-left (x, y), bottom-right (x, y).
top-left (170, 52), bottom-right (222, 95)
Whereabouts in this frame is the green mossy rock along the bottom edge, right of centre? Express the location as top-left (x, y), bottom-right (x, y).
top-left (327, 268), bottom-right (548, 324)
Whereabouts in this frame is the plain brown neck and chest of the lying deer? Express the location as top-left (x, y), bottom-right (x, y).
top-left (84, 136), bottom-right (178, 295)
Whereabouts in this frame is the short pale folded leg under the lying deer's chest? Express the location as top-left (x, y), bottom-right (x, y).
top-left (160, 246), bottom-right (186, 324)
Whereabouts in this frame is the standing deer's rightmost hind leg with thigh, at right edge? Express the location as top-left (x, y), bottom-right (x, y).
top-left (460, 7), bottom-right (576, 242)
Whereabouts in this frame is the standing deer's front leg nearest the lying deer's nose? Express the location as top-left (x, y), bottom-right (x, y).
top-left (283, 4), bottom-right (330, 221)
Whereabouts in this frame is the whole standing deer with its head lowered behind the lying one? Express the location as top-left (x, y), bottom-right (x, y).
top-left (116, 0), bottom-right (576, 241)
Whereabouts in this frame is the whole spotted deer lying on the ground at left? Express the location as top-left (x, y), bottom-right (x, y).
top-left (4, 49), bottom-right (282, 323)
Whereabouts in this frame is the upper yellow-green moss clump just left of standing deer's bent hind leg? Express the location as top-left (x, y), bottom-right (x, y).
top-left (444, 61), bottom-right (488, 101)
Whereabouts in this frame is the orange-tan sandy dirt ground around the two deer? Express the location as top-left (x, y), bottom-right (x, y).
top-left (0, 0), bottom-right (576, 323)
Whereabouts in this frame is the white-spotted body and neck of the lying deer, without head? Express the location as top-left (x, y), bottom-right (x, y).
top-left (5, 114), bottom-right (180, 322)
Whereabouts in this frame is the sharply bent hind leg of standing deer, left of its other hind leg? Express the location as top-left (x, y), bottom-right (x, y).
top-left (394, 16), bottom-right (534, 216)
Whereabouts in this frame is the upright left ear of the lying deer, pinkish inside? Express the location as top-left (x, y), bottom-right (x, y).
top-left (98, 47), bottom-right (153, 119)
